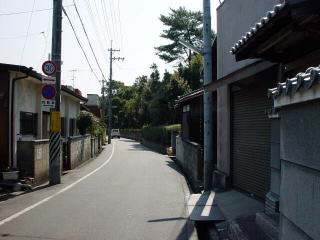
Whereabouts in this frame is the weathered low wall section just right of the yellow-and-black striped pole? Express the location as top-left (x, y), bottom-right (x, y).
top-left (67, 134), bottom-right (91, 169)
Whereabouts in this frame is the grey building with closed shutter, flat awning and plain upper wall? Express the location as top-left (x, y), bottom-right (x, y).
top-left (205, 0), bottom-right (279, 200)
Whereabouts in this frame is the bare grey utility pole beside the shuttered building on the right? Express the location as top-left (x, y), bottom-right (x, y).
top-left (203, 0), bottom-right (213, 191)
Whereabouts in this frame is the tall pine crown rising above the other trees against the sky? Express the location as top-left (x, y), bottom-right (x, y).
top-left (155, 7), bottom-right (202, 63)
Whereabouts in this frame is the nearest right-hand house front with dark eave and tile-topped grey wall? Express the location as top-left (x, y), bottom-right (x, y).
top-left (231, 0), bottom-right (320, 239)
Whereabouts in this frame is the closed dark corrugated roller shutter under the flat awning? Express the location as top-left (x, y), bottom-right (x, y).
top-left (232, 84), bottom-right (272, 198)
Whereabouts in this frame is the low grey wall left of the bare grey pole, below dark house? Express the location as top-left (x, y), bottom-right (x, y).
top-left (176, 136), bottom-right (203, 192)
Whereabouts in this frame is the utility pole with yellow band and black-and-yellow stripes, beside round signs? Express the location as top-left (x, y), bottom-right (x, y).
top-left (49, 0), bottom-right (62, 185)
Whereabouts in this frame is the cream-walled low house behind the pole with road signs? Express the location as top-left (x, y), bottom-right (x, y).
top-left (0, 64), bottom-right (87, 168)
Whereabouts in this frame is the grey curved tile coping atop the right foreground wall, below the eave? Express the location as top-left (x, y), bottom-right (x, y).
top-left (268, 66), bottom-right (320, 99)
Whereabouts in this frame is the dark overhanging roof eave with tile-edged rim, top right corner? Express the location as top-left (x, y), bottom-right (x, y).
top-left (230, 0), bottom-right (320, 63)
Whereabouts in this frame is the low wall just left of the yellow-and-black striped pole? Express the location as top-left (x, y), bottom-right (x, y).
top-left (17, 139), bottom-right (49, 185)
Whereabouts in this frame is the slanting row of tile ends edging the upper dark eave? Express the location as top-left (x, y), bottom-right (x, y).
top-left (230, 2), bottom-right (286, 54)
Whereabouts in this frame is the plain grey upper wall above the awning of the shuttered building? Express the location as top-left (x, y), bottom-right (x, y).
top-left (217, 0), bottom-right (280, 79)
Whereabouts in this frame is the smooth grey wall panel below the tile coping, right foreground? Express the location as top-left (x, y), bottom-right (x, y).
top-left (280, 100), bottom-right (320, 240)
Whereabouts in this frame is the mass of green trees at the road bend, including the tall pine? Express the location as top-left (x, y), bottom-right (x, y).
top-left (102, 7), bottom-right (214, 131)
